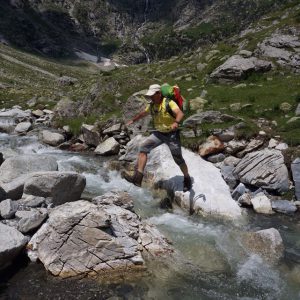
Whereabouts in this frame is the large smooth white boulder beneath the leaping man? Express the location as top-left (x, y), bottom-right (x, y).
top-left (120, 136), bottom-right (241, 218)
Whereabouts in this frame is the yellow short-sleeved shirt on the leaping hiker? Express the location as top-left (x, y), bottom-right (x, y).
top-left (145, 98), bottom-right (179, 132)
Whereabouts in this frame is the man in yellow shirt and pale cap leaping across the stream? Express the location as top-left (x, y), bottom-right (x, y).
top-left (123, 84), bottom-right (192, 192)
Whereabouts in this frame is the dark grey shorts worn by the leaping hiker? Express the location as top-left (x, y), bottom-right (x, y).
top-left (140, 130), bottom-right (185, 166)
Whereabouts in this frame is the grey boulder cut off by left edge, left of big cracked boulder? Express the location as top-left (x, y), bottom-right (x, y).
top-left (0, 223), bottom-right (27, 270)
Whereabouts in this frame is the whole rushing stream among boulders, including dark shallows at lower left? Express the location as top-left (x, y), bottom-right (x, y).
top-left (0, 134), bottom-right (300, 300)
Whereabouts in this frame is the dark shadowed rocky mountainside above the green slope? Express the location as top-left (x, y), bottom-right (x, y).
top-left (0, 0), bottom-right (293, 63)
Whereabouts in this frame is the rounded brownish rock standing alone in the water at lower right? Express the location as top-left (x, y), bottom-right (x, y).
top-left (242, 228), bottom-right (284, 263)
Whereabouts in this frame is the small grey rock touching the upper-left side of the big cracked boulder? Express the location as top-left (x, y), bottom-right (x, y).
top-left (18, 210), bottom-right (48, 234)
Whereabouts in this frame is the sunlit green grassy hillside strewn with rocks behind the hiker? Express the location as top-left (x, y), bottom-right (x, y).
top-left (0, 1), bottom-right (300, 146)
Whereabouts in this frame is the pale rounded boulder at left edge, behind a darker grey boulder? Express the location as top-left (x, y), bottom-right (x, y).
top-left (0, 155), bottom-right (58, 200)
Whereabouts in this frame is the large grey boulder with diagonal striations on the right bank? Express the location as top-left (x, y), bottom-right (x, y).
top-left (234, 149), bottom-right (289, 192)
